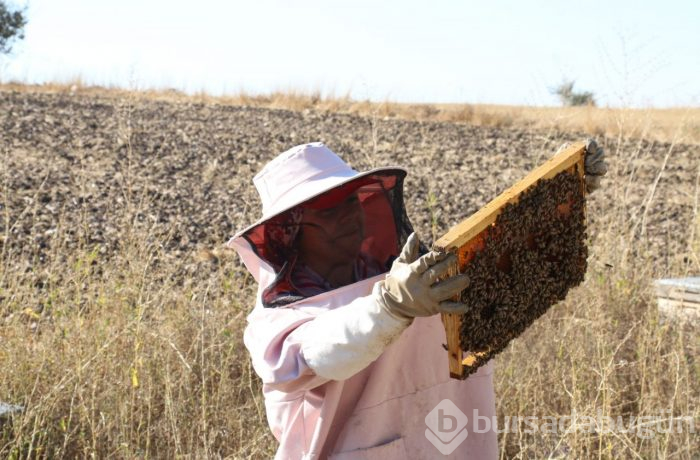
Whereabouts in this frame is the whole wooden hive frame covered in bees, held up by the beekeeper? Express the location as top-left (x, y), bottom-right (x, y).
top-left (433, 142), bottom-right (587, 379)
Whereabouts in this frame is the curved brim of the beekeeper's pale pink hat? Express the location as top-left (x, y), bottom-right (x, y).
top-left (226, 167), bottom-right (408, 246)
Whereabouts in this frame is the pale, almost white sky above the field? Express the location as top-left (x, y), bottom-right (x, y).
top-left (0, 0), bottom-right (700, 107)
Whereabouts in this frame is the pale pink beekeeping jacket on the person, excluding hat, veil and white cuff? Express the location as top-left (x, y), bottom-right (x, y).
top-left (229, 238), bottom-right (498, 460)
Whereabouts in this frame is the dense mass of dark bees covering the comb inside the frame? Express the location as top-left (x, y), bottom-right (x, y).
top-left (459, 167), bottom-right (588, 378)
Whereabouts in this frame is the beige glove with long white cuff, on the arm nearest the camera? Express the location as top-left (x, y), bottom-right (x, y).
top-left (294, 234), bottom-right (468, 380)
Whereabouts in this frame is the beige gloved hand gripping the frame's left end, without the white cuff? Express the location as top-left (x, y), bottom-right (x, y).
top-left (375, 233), bottom-right (469, 318)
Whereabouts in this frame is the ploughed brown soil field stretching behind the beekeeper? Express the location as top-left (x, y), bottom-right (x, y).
top-left (0, 91), bottom-right (700, 284)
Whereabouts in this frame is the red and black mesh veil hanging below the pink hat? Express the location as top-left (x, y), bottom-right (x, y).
top-left (243, 170), bottom-right (413, 307)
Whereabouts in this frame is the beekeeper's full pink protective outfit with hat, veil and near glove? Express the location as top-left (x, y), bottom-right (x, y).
top-left (228, 143), bottom-right (498, 460)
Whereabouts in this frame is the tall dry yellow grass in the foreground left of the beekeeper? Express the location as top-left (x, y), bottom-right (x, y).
top-left (0, 171), bottom-right (274, 458)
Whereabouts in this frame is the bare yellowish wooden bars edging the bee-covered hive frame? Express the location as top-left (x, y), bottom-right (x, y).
top-left (433, 142), bottom-right (586, 379)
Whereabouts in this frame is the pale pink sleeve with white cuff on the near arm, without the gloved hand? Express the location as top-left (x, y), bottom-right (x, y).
top-left (244, 285), bottom-right (411, 392)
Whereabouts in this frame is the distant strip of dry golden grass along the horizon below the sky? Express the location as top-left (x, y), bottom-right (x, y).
top-left (0, 80), bottom-right (700, 144)
